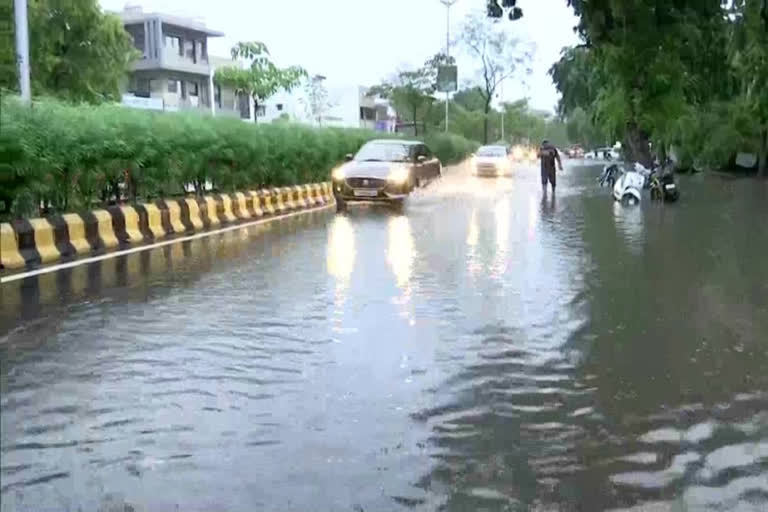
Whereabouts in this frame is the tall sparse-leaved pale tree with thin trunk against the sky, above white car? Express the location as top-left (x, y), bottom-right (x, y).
top-left (461, 13), bottom-right (531, 143)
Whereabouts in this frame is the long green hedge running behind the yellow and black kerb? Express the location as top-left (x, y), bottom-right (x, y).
top-left (0, 98), bottom-right (476, 218)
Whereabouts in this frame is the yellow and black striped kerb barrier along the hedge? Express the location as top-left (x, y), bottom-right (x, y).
top-left (0, 183), bottom-right (333, 269)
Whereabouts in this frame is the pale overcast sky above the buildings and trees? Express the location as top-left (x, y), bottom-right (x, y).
top-left (101, 0), bottom-right (577, 110)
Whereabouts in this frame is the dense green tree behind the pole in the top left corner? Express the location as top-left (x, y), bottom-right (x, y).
top-left (0, 0), bottom-right (138, 102)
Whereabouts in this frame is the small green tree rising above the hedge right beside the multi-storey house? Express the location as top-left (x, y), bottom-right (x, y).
top-left (214, 41), bottom-right (307, 123)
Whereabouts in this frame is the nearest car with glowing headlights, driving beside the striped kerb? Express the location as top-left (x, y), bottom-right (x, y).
top-left (331, 139), bottom-right (443, 211)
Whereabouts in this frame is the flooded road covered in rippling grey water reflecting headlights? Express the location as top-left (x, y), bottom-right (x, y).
top-left (0, 164), bottom-right (768, 512)
